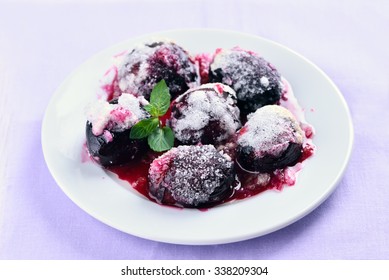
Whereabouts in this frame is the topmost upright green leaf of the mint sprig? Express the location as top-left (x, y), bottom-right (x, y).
top-left (145, 80), bottom-right (170, 117)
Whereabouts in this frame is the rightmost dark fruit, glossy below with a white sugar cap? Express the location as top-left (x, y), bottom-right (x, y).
top-left (236, 105), bottom-right (304, 172)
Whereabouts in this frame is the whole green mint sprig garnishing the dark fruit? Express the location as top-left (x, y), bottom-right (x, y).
top-left (130, 80), bottom-right (174, 152)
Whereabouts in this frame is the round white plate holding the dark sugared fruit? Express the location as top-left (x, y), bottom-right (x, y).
top-left (42, 30), bottom-right (353, 244)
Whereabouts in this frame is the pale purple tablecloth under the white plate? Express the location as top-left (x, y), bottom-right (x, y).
top-left (0, 0), bottom-right (389, 259)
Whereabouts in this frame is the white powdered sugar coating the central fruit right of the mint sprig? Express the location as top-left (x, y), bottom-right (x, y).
top-left (170, 83), bottom-right (241, 144)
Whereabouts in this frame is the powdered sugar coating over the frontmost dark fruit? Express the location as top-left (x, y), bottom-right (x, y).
top-left (149, 145), bottom-right (234, 206)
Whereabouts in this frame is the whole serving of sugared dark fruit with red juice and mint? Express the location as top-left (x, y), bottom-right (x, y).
top-left (82, 40), bottom-right (315, 208)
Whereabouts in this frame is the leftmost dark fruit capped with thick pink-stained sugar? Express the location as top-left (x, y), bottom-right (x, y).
top-left (86, 94), bottom-right (149, 167)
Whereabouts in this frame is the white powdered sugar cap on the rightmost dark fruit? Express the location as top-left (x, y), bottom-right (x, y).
top-left (238, 105), bottom-right (304, 157)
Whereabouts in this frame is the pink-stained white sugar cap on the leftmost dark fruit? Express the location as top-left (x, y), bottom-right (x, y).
top-left (86, 94), bottom-right (148, 136)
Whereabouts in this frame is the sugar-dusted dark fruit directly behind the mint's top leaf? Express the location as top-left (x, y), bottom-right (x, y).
top-left (118, 41), bottom-right (200, 100)
